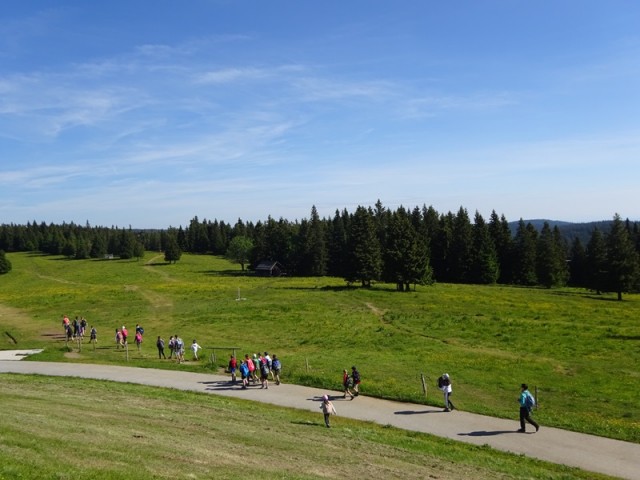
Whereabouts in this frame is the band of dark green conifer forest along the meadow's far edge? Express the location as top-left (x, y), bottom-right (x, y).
top-left (0, 201), bottom-right (640, 299)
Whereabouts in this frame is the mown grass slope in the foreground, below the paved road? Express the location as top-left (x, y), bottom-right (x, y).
top-left (0, 374), bottom-right (616, 480)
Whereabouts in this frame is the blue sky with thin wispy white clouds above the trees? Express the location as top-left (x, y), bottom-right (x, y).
top-left (0, 0), bottom-right (640, 228)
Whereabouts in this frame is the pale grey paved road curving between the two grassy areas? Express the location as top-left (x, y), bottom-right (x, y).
top-left (0, 351), bottom-right (640, 480)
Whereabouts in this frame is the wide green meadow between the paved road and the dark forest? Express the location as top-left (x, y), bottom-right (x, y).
top-left (0, 253), bottom-right (640, 443)
